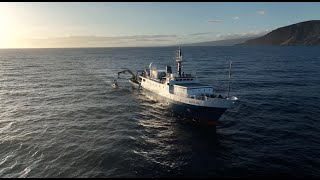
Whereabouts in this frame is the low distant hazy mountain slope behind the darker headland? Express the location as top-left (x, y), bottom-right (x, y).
top-left (179, 36), bottom-right (257, 46)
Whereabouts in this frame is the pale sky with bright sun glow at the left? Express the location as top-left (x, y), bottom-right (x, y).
top-left (0, 2), bottom-right (320, 48)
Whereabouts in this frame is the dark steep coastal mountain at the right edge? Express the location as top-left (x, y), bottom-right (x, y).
top-left (237, 20), bottom-right (320, 46)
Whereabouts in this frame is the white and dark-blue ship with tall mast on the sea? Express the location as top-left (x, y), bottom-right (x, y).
top-left (118, 48), bottom-right (238, 125)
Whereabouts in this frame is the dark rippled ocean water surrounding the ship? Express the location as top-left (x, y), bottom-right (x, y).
top-left (0, 46), bottom-right (320, 178)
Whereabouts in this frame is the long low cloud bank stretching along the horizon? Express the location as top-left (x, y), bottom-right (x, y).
top-left (17, 30), bottom-right (267, 48)
